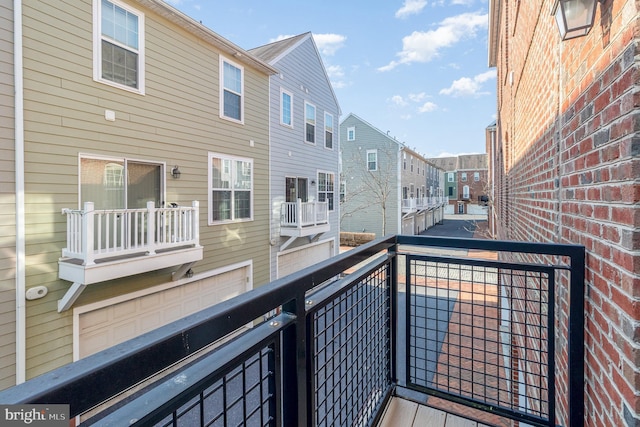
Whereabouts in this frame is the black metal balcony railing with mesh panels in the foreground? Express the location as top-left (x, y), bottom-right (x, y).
top-left (0, 236), bottom-right (584, 426)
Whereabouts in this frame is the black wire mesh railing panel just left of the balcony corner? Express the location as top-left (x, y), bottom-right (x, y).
top-left (312, 264), bottom-right (391, 426)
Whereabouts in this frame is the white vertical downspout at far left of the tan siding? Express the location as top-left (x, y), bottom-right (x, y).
top-left (13, 0), bottom-right (26, 384)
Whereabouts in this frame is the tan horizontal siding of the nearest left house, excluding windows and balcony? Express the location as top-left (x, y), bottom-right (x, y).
top-left (24, 0), bottom-right (269, 378)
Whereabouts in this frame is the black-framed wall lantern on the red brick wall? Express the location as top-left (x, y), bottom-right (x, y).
top-left (553, 0), bottom-right (604, 40)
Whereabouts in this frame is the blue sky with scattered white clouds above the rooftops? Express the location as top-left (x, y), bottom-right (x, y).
top-left (166, 0), bottom-right (496, 157)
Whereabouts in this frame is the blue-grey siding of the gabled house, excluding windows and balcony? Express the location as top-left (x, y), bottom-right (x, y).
top-left (262, 37), bottom-right (340, 279)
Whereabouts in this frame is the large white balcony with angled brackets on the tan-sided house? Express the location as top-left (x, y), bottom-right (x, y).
top-left (58, 201), bottom-right (203, 311)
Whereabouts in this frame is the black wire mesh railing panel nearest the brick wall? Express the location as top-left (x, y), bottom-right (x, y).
top-left (407, 257), bottom-right (555, 422)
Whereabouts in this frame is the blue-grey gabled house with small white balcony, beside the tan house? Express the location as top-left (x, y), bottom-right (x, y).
top-left (250, 33), bottom-right (340, 279)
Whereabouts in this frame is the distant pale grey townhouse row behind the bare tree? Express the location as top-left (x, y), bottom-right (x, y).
top-left (340, 113), bottom-right (447, 237)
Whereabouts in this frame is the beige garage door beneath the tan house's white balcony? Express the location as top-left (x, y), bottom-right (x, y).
top-left (78, 266), bottom-right (250, 358)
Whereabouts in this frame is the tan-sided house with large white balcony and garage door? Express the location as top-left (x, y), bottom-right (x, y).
top-left (0, 0), bottom-right (275, 388)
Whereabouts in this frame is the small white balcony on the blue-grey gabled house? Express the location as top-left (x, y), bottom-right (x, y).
top-left (280, 199), bottom-right (331, 250)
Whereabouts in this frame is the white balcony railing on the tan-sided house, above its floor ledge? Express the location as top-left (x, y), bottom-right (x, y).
top-left (62, 201), bottom-right (199, 266)
